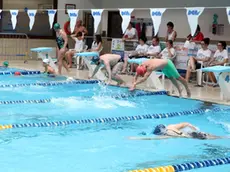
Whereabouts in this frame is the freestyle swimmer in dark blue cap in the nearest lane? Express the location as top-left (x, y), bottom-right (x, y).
top-left (129, 122), bottom-right (230, 140)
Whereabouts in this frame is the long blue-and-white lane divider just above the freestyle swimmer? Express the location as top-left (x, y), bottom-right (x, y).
top-left (0, 108), bottom-right (227, 129)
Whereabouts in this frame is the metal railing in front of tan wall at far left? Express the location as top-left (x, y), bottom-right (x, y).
top-left (0, 33), bottom-right (29, 60)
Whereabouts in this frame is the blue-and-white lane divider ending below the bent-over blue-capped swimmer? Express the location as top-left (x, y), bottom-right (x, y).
top-left (0, 80), bottom-right (100, 88)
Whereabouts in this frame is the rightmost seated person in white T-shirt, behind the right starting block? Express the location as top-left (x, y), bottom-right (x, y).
top-left (208, 41), bottom-right (228, 86)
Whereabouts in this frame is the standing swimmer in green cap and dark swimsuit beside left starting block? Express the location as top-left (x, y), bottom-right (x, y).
top-left (54, 23), bottom-right (69, 75)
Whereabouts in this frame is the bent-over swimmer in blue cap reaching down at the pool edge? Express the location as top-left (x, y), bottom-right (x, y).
top-left (89, 54), bottom-right (125, 85)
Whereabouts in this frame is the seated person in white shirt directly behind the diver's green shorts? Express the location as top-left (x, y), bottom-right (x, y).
top-left (158, 40), bottom-right (176, 61)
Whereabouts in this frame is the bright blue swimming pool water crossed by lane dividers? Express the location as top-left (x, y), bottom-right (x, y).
top-left (0, 75), bottom-right (230, 172)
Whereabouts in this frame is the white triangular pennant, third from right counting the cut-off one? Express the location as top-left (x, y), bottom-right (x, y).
top-left (150, 8), bottom-right (166, 36)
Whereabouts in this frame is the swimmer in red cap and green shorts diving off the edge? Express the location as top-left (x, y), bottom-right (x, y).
top-left (130, 59), bottom-right (191, 97)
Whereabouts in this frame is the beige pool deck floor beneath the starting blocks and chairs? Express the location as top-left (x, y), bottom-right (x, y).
top-left (5, 60), bottom-right (230, 105)
